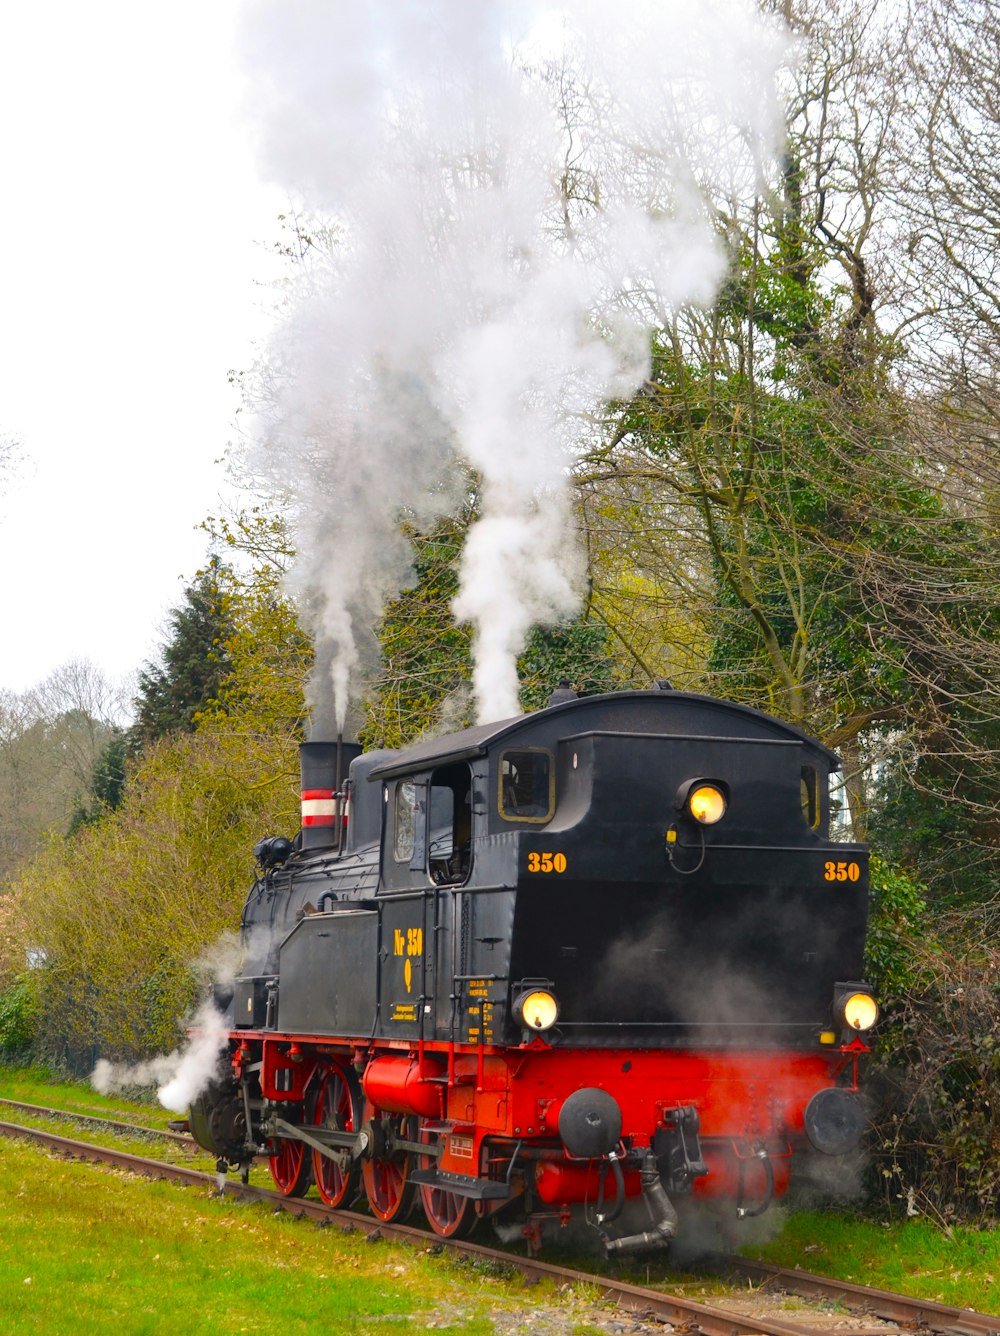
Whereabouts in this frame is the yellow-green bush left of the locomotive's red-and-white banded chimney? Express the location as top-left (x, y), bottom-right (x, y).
top-left (16, 721), bottom-right (298, 1067)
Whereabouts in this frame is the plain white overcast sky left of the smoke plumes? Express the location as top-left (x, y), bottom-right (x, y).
top-left (0, 0), bottom-right (284, 691)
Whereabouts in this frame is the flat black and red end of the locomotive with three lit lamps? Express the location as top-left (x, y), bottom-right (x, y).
top-left (499, 720), bottom-right (877, 1250)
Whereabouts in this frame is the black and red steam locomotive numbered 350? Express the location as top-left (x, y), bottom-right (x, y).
top-left (190, 689), bottom-right (877, 1253)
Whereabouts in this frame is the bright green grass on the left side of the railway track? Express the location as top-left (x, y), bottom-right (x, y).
top-left (0, 1069), bottom-right (597, 1336)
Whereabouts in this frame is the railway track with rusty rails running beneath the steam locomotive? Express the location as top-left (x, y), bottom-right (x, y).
top-left (0, 1101), bottom-right (1000, 1336)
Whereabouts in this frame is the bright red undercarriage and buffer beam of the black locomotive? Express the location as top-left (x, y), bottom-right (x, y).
top-left (224, 1030), bottom-right (866, 1232)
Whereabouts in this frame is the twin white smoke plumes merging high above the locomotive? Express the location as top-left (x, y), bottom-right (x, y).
top-left (236, 0), bottom-right (784, 721)
